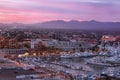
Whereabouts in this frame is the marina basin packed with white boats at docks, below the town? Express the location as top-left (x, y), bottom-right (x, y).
top-left (16, 46), bottom-right (120, 80)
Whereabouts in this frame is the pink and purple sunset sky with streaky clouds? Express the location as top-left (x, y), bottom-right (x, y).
top-left (0, 0), bottom-right (120, 23)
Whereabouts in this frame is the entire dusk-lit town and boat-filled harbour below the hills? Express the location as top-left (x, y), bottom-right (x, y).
top-left (0, 24), bottom-right (120, 80)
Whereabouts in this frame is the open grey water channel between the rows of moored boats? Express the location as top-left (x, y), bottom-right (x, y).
top-left (60, 58), bottom-right (120, 75)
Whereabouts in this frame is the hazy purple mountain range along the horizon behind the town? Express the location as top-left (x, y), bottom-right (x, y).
top-left (0, 20), bottom-right (120, 31)
